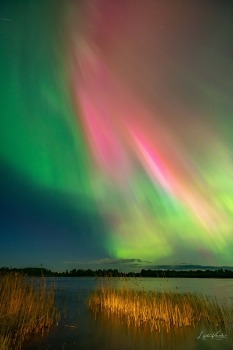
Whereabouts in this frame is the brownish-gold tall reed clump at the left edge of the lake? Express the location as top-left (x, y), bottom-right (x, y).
top-left (0, 274), bottom-right (59, 350)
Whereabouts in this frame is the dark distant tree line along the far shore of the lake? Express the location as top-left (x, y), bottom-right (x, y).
top-left (0, 267), bottom-right (233, 278)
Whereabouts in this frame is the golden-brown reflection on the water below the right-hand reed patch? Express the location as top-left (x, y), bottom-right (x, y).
top-left (92, 313), bottom-right (232, 350)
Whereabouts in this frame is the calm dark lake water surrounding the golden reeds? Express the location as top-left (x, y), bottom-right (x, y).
top-left (23, 277), bottom-right (233, 350)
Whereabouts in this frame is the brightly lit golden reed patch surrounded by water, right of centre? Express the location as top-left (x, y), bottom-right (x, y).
top-left (88, 286), bottom-right (233, 332)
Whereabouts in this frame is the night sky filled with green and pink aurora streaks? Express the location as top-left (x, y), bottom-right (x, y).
top-left (0, 0), bottom-right (233, 269)
